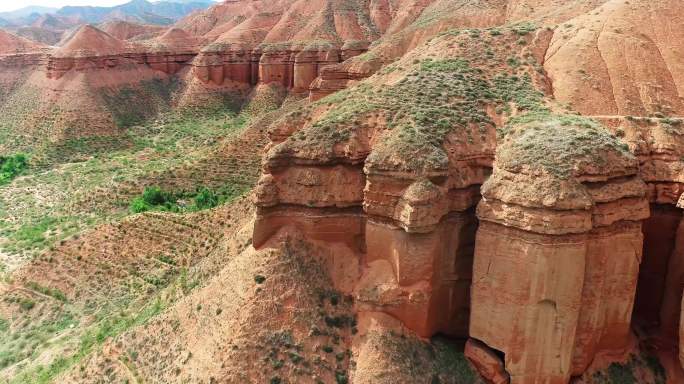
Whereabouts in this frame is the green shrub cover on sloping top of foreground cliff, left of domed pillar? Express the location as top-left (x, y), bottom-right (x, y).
top-left (281, 31), bottom-right (547, 172)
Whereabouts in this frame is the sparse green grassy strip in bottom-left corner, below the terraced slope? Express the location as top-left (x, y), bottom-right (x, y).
top-left (0, 242), bottom-right (203, 384)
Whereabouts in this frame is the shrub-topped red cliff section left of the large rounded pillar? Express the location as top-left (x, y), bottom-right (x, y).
top-left (254, 22), bottom-right (532, 344)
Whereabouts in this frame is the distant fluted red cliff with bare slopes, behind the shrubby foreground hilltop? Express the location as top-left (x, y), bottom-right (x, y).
top-left (179, 1), bottom-right (379, 92)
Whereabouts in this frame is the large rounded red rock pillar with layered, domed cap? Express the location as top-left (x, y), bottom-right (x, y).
top-left (470, 118), bottom-right (649, 384)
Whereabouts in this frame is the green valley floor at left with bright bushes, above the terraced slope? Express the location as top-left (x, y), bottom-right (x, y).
top-left (0, 100), bottom-right (260, 259)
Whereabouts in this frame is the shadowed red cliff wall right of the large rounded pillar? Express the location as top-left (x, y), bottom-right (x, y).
top-left (599, 112), bottom-right (684, 382)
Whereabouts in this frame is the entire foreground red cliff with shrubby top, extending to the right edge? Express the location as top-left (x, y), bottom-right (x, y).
top-left (254, 2), bottom-right (684, 383)
